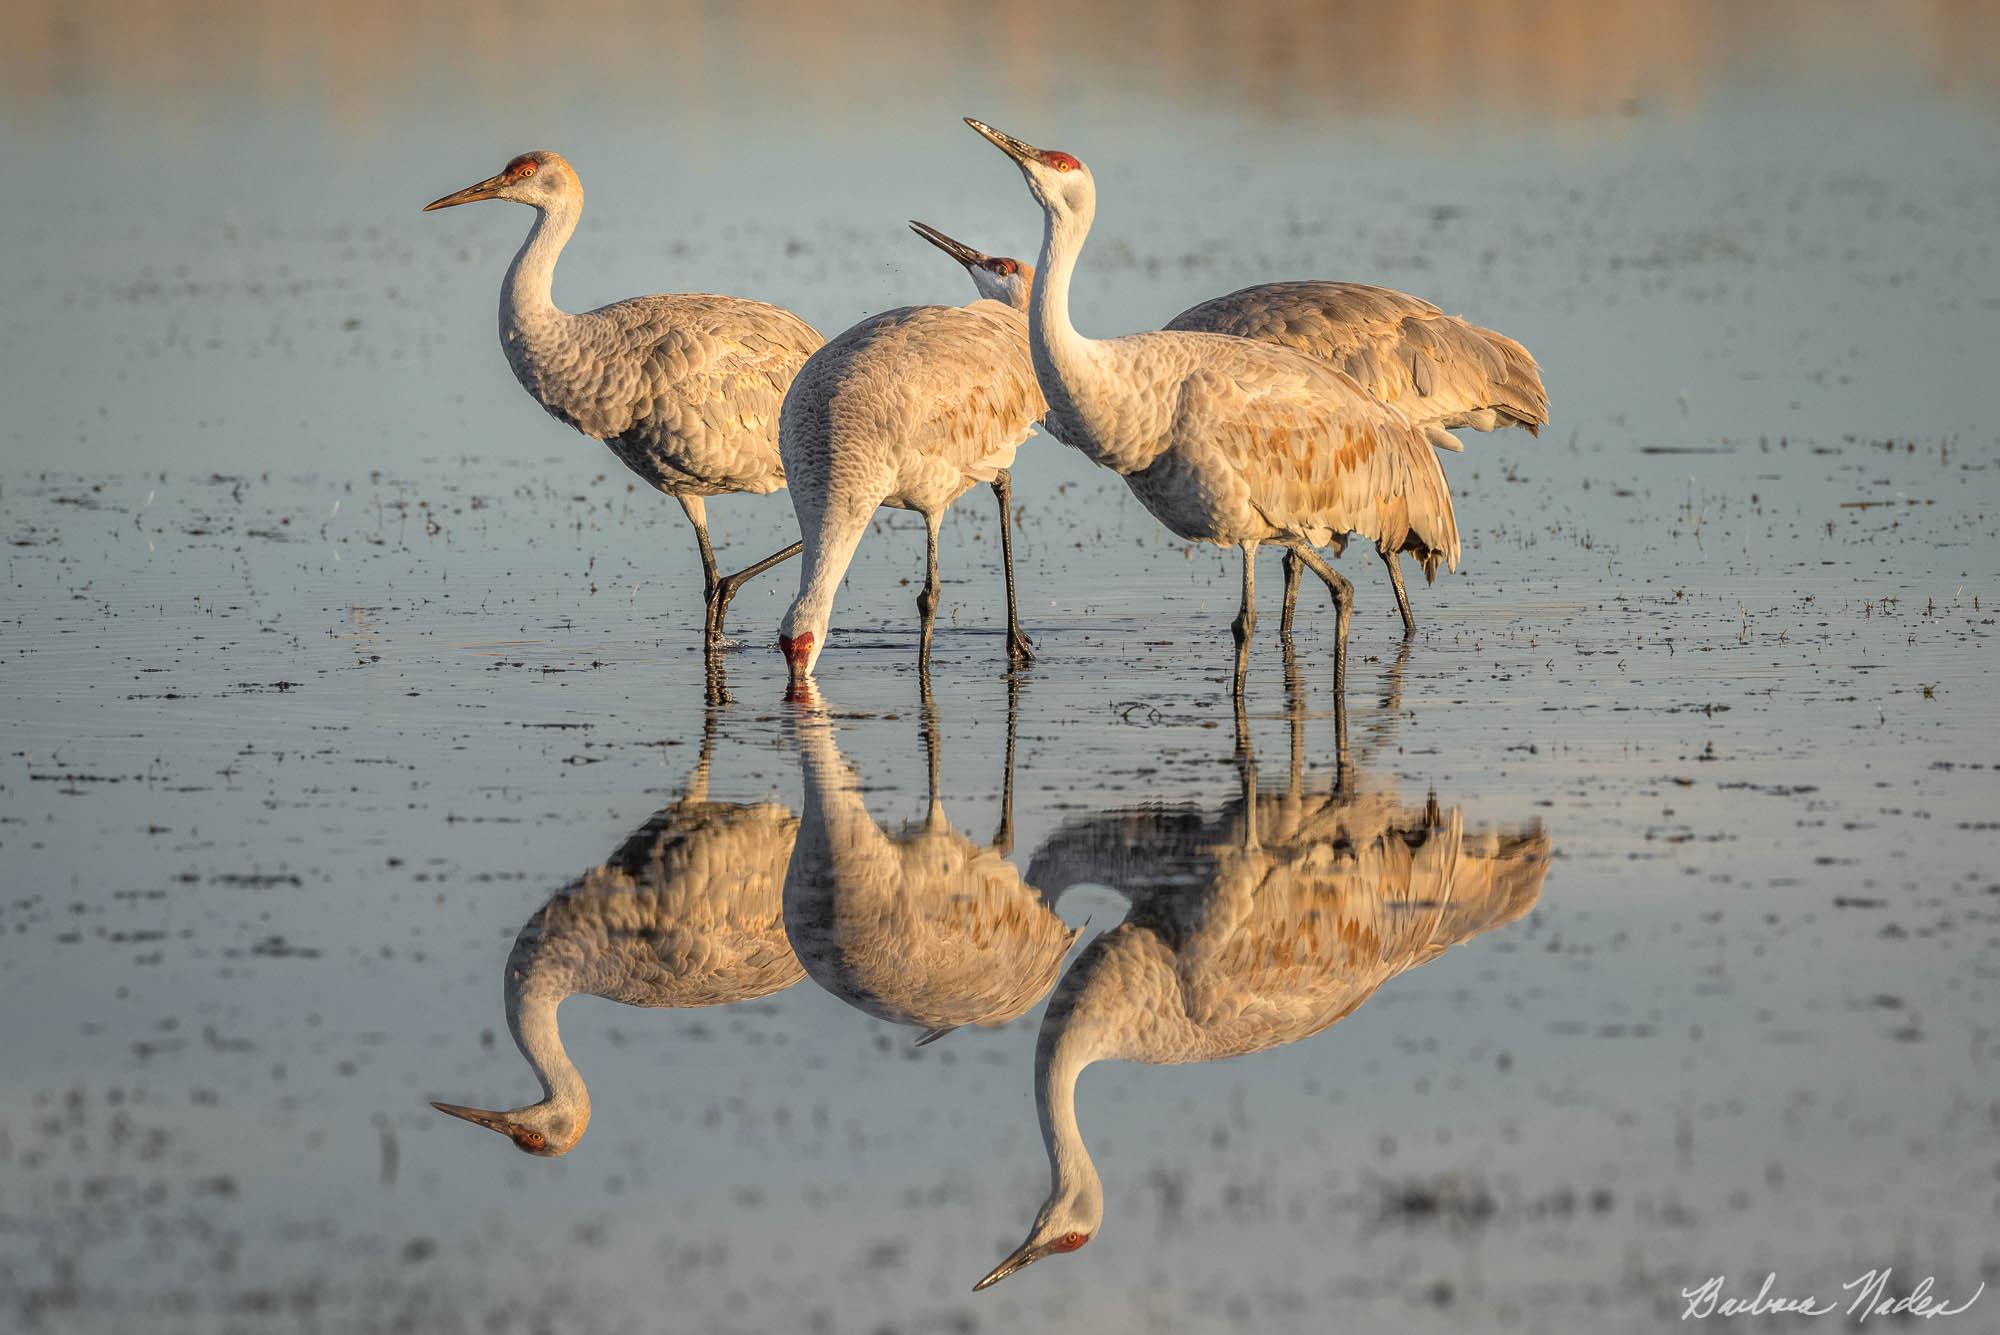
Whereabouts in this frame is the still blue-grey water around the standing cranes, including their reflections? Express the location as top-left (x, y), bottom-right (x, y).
top-left (0, 2), bottom-right (2000, 1333)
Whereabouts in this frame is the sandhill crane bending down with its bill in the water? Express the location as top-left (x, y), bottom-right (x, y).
top-left (778, 224), bottom-right (1044, 685)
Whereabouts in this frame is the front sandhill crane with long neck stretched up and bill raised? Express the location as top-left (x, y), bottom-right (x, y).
top-left (966, 118), bottom-right (1458, 697)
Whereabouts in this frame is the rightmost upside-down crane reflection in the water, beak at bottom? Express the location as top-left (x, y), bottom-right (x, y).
top-left (974, 715), bottom-right (1550, 1291)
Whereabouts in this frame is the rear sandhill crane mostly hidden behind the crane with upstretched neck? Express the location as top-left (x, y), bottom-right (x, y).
top-left (922, 228), bottom-right (1548, 638)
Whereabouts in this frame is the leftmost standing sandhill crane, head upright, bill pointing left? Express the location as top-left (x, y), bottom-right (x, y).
top-left (424, 150), bottom-right (824, 652)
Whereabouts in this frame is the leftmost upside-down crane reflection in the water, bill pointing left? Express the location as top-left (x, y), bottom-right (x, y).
top-left (432, 717), bottom-right (806, 1157)
